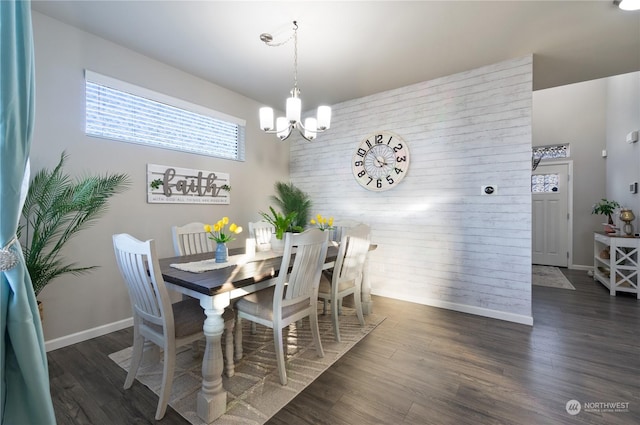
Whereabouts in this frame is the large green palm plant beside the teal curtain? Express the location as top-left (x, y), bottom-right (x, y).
top-left (18, 152), bottom-right (129, 295)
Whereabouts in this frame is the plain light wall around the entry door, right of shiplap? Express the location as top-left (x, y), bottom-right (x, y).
top-left (533, 72), bottom-right (640, 268)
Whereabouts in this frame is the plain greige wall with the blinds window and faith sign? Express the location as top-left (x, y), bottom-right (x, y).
top-left (31, 12), bottom-right (289, 346)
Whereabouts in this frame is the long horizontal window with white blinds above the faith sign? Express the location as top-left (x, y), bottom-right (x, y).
top-left (85, 70), bottom-right (245, 161)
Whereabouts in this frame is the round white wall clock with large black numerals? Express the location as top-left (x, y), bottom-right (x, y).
top-left (351, 131), bottom-right (409, 192)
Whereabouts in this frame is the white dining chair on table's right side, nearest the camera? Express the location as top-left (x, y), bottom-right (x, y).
top-left (236, 229), bottom-right (328, 385)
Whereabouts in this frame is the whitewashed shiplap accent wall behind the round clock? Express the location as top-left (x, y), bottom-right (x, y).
top-left (290, 56), bottom-right (533, 324)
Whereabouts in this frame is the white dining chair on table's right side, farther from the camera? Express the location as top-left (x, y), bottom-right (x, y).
top-left (318, 224), bottom-right (370, 342)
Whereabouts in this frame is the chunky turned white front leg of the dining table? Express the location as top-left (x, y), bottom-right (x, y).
top-left (196, 296), bottom-right (229, 423)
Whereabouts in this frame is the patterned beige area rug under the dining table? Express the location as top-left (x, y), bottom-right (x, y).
top-left (109, 307), bottom-right (385, 425)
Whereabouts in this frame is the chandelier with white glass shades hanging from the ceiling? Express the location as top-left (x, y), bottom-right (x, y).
top-left (260, 21), bottom-right (331, 141)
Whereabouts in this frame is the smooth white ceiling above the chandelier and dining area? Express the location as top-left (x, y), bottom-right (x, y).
top-left (32, 0), bottom-right (640, 109)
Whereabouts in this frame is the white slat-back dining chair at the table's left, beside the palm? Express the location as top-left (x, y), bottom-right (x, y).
top-left (113, 233), bottom-right (234, 420)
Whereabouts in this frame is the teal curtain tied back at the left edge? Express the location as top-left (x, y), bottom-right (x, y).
top-left (0, 0), bottom-right (56, 425)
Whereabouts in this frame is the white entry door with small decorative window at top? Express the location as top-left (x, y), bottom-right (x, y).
top-left (531, 163), bottom-right (570, 267)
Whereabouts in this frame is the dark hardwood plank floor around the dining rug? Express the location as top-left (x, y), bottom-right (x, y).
top-left (48, 270), bottom-right (640, 425)
